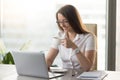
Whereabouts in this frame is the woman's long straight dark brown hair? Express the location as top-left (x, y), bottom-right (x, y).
top-left (56, 5), bottom-right (88, 34)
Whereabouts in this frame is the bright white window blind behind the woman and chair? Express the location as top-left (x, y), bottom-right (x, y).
top-left (0, 0), bottom-right (106, 69)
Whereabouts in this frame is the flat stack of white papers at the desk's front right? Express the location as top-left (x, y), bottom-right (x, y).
top-left (77, 71), bottom-right (107, 80)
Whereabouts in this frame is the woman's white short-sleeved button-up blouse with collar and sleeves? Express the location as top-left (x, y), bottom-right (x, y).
top-left (52, 32), bottom-right (96, 69)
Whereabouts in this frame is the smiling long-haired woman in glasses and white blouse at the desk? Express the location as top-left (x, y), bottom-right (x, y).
top-left (46, 5), bottom-right (96, 71)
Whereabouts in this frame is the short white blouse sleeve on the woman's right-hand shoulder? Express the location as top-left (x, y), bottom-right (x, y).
top-left (86, 34), bottom-right (97, 50)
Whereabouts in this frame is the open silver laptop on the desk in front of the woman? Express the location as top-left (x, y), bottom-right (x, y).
top-left (11, 51), bottom-right (64, 79)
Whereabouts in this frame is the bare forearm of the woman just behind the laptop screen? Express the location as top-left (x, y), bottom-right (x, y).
top-left (46, 48), bottom-right (58, 69)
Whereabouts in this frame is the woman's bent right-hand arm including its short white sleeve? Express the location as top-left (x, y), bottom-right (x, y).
top-left (72, 36), bottom-right (96, 71)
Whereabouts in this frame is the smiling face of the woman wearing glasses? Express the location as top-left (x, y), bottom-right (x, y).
top-left (57, 13), bottom-right (72, 32)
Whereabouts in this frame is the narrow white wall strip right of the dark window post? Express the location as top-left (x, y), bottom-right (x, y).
top-left (116, 0), bottom-right (120, 71)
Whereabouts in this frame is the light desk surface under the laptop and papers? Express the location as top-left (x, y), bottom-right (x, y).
top-left (0, 64), bottom-right (120, 80)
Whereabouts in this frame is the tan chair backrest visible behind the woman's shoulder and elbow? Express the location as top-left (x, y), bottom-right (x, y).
top-left (85, 24), bottom-right (97, 70)
